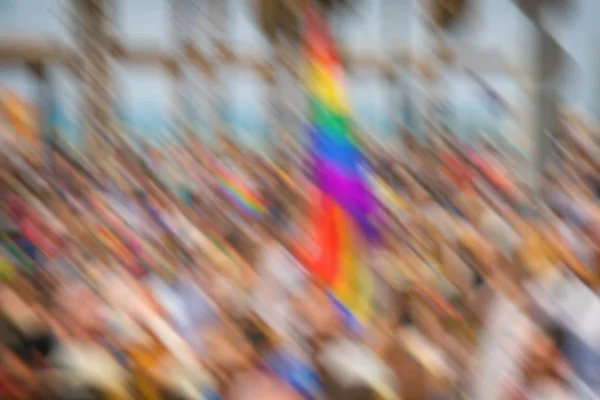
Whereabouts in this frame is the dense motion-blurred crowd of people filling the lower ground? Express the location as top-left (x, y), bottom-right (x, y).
top-left (0, 126), bottom-right (600, 400)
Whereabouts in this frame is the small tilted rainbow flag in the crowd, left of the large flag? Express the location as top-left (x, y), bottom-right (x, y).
top-left (216, 168), bottom-right (267, 217)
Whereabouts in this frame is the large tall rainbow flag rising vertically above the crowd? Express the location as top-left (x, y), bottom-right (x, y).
top-left (304, 6), bottom-right (376, 321)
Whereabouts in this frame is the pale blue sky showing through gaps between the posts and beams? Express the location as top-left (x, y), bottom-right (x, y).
top-left (0, 0), bottom-right (600, 144)
